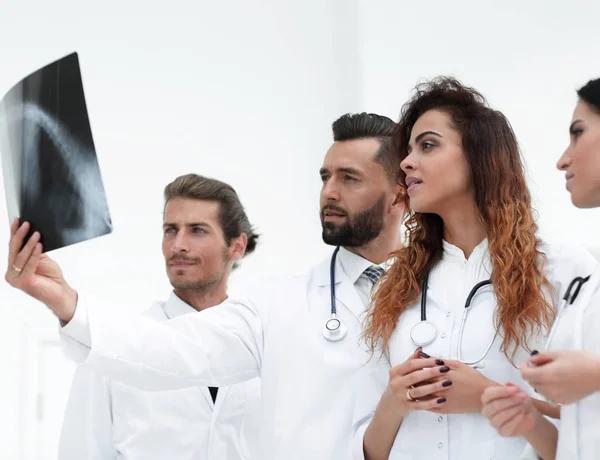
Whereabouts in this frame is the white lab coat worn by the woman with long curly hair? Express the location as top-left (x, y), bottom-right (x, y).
top-left (354, 240), bottom-right (597, 460)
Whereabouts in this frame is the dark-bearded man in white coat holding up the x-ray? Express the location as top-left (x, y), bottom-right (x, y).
top-left (6, 113), bottom-right (404, 460)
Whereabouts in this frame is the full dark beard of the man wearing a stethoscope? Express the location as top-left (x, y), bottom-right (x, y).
top-left (321, 194), bottom-right (385, 247)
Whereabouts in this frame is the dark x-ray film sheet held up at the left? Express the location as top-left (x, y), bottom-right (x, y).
top-left (0, 53), bottom-right (112, 252)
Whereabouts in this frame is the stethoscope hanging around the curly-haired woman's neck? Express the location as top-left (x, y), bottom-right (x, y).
top-left (410, 273), bottom-right (498, 367)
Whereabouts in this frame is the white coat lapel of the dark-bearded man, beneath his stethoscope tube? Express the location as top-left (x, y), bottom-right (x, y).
top-left (316, 252), bottom-right (366, 321)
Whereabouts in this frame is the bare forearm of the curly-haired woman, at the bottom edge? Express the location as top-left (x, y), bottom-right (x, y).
top-left (363, 388), bottom-right (404, 460)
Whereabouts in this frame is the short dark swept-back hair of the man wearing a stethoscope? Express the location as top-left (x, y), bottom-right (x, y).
top-left (332, 112), bottom-right (400, 182)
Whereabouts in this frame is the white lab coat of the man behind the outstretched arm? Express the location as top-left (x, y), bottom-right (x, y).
top-left (59, 293), bottom-right (260, 460)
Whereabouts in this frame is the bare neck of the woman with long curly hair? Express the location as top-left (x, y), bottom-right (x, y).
top-left (440, 200), bottom-right (486, 259)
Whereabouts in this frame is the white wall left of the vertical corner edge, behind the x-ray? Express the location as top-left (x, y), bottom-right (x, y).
top-left (0, 0), bottom-right (359, 460)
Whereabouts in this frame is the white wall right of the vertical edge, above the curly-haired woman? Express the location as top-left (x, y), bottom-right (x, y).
top-left (358, 0), bottom-right (600, 255)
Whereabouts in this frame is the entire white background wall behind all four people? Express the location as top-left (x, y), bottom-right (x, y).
top-left (0, 0), bottom-right (600, 460)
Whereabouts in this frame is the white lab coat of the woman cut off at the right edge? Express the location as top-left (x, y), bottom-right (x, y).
top-left (532, 260), bottom-right (600, 460)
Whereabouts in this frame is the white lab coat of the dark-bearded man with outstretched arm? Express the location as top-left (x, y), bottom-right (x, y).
top-left (61, 249), bottom-right (390, 460)
